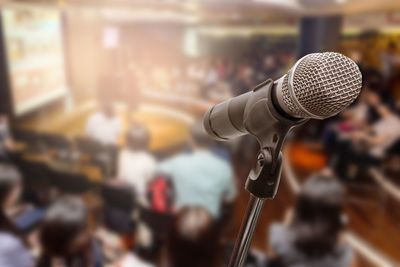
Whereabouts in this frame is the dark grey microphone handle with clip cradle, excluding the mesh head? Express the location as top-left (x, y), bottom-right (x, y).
top-left (203, 79), bottom-right (307, 147)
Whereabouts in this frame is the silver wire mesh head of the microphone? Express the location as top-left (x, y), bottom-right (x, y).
top-left (282, 52), bottom-right (361, 119)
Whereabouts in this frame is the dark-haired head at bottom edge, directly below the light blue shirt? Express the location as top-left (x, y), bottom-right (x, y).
top-left (167, 207), bottom-right (223, 267)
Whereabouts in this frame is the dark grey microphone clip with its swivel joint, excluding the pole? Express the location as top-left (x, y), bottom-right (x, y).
top-left (244, 80), bottom-right (308, 199)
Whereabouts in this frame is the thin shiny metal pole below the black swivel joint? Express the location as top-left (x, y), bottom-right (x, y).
top-left (229, 195), bottom-right (265, 267)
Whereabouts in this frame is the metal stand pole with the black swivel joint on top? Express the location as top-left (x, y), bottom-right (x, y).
top-left (228, 148), bottom-right (283, 267)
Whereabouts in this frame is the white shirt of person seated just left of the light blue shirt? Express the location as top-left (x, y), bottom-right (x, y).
top-left (118, 149), bottom-right (156, 195)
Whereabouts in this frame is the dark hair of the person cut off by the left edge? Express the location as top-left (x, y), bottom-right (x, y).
top-left (0, 163), bottom-right (21, 237)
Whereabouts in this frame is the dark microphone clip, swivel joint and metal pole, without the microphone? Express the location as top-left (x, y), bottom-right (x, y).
top-left (228, 80), bottom-right (307, 267)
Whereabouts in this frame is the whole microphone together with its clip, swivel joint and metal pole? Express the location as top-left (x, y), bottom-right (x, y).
top-left (212, 52), bottom-right (361, 267)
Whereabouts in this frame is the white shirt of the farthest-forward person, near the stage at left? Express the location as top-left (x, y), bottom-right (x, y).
top-left (86, 112), bottom-right (122, 145)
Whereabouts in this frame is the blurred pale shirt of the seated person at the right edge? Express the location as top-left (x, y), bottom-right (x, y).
top-left (370, 116), bottom-right (400, 158)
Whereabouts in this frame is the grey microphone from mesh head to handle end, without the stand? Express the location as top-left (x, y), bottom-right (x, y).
top-left (203, 52), bottom-right (361, 144)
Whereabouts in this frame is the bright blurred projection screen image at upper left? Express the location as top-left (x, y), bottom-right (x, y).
top-left (2, 7), bottom-right (67, 115)
